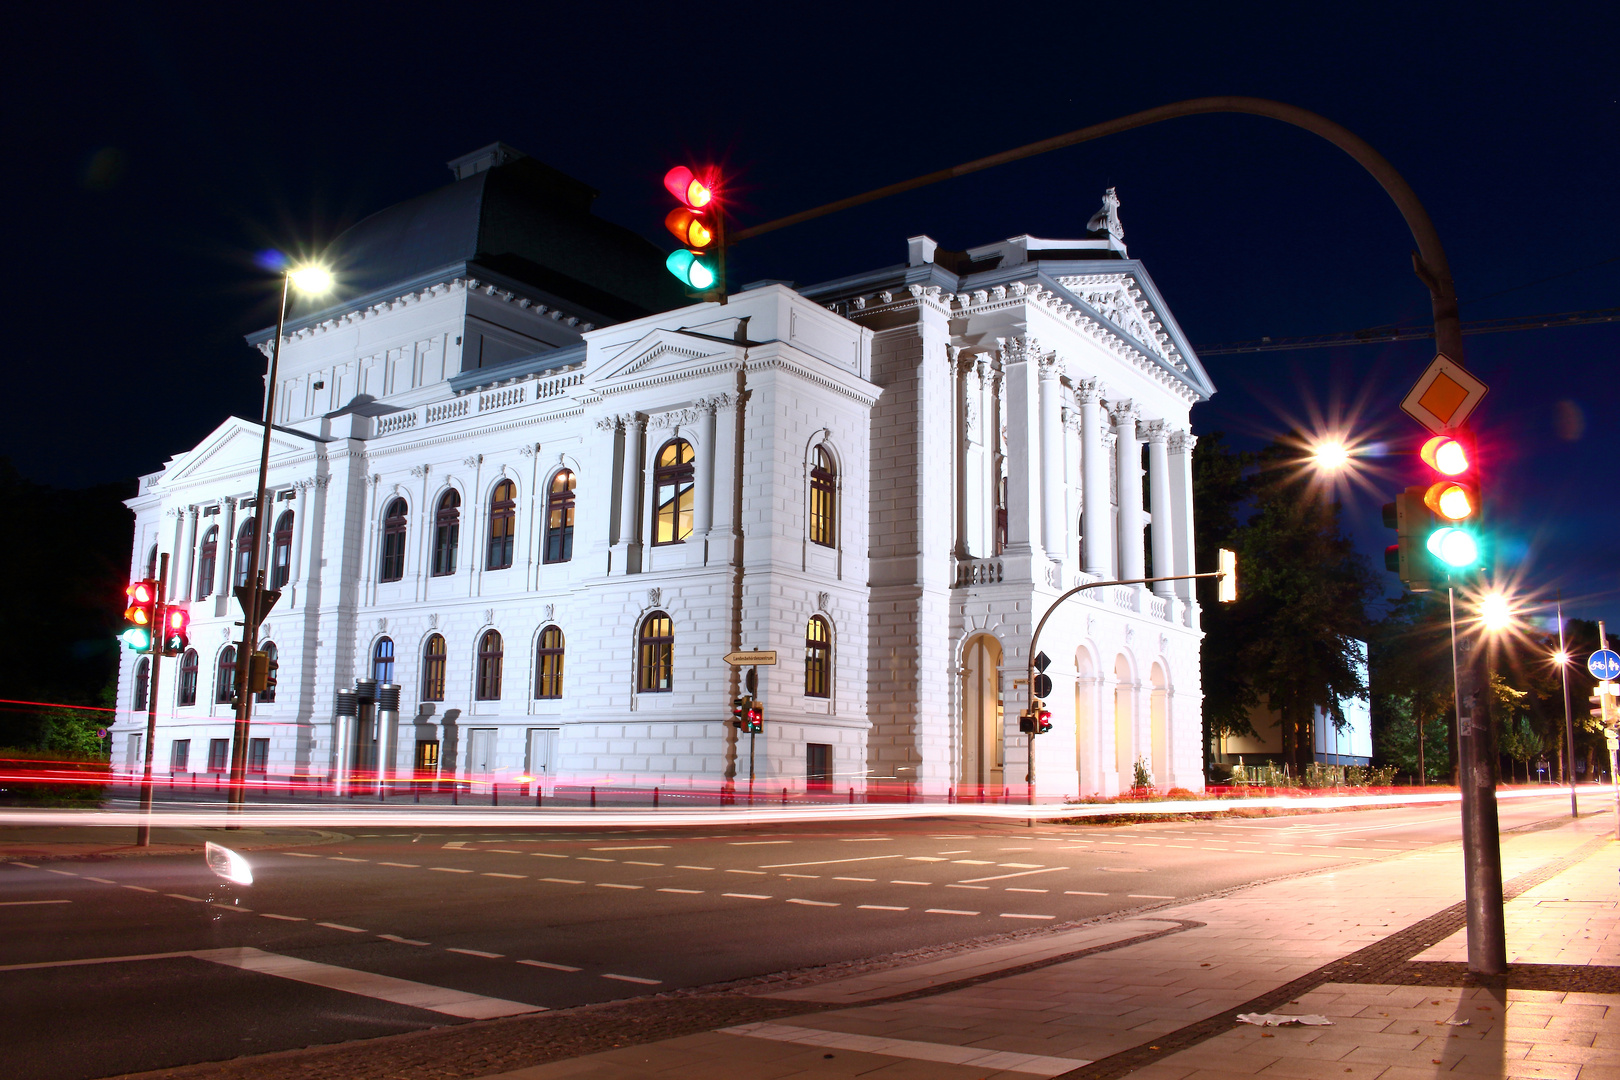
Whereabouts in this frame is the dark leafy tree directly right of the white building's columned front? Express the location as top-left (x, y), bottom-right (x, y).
top-left (1194, 436), bottom-right (1372, 774)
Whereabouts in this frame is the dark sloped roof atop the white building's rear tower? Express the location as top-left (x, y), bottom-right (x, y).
top-left (288, 144), bottom-right (690, 322)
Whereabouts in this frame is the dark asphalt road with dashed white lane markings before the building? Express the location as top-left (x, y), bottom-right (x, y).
top-left (0, 795), bottom-right (1594, 1080)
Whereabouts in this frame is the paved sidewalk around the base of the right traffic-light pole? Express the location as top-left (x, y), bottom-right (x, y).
top-left (479, 816), bottom-right (1620, 1080)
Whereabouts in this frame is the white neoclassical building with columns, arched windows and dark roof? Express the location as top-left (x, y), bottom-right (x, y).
top-left (113, 144), bottom-right (1213, 795)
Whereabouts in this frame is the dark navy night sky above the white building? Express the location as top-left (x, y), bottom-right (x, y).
top-left (0, 2), bottom-right (1620, 625)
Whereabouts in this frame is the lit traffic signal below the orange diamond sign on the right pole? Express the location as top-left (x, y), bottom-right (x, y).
top-left (1383, 436), bottom-right (1481, 593)
